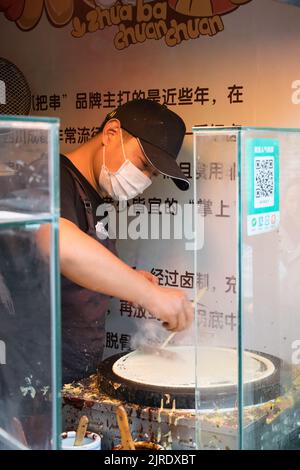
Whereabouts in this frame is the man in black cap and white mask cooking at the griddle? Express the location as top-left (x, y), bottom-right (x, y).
top-left (39, 100), bottom-right (193, 383)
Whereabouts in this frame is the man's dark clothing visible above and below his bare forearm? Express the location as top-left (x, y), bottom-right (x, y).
top-left (60, 155), bottom-right (115, 383)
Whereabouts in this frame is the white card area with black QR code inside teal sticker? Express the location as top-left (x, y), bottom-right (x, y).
top-left (254, 156), bottom-right (275, 209)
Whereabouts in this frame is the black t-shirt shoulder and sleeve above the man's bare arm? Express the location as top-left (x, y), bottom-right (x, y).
top-left (60, 155), bottom-right (105, 232)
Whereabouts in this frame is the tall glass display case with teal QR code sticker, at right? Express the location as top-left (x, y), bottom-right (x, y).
top-left (193, 127), bottom-right (300, 450)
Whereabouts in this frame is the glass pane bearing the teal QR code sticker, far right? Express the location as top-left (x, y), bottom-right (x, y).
top-left (240, 129), bottom-right (300, 449)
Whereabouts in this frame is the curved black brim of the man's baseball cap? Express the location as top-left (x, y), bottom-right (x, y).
top-left (138, 139), bottom-right (190, 191)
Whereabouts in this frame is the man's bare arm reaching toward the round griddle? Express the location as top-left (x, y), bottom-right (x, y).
top-left (37, 218), bottom-right (193, 331)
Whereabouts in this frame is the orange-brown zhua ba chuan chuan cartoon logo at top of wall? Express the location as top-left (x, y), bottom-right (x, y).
top-left (0, 0), bottom-right (252, 50)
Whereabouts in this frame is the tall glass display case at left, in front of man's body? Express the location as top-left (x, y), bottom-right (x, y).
top-left (0, 116), bottom-right (61, 449)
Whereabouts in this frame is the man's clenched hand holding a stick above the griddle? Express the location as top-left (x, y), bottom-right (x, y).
top-left (141, 285), bottom-right (194, 331)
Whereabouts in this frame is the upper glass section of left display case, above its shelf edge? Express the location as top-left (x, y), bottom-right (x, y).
top-left (0, 119), bottom-right (58, 220)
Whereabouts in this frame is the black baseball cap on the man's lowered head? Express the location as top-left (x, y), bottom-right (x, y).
top-left (101, 99), bottom-right (190, 191)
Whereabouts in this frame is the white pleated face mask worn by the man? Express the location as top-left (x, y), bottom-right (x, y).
top-left (99, 130), bottom-right (152, 201)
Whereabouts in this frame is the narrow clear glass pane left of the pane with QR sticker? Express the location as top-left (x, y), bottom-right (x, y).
top-left (194, 128), bottom-right (239, 449)
